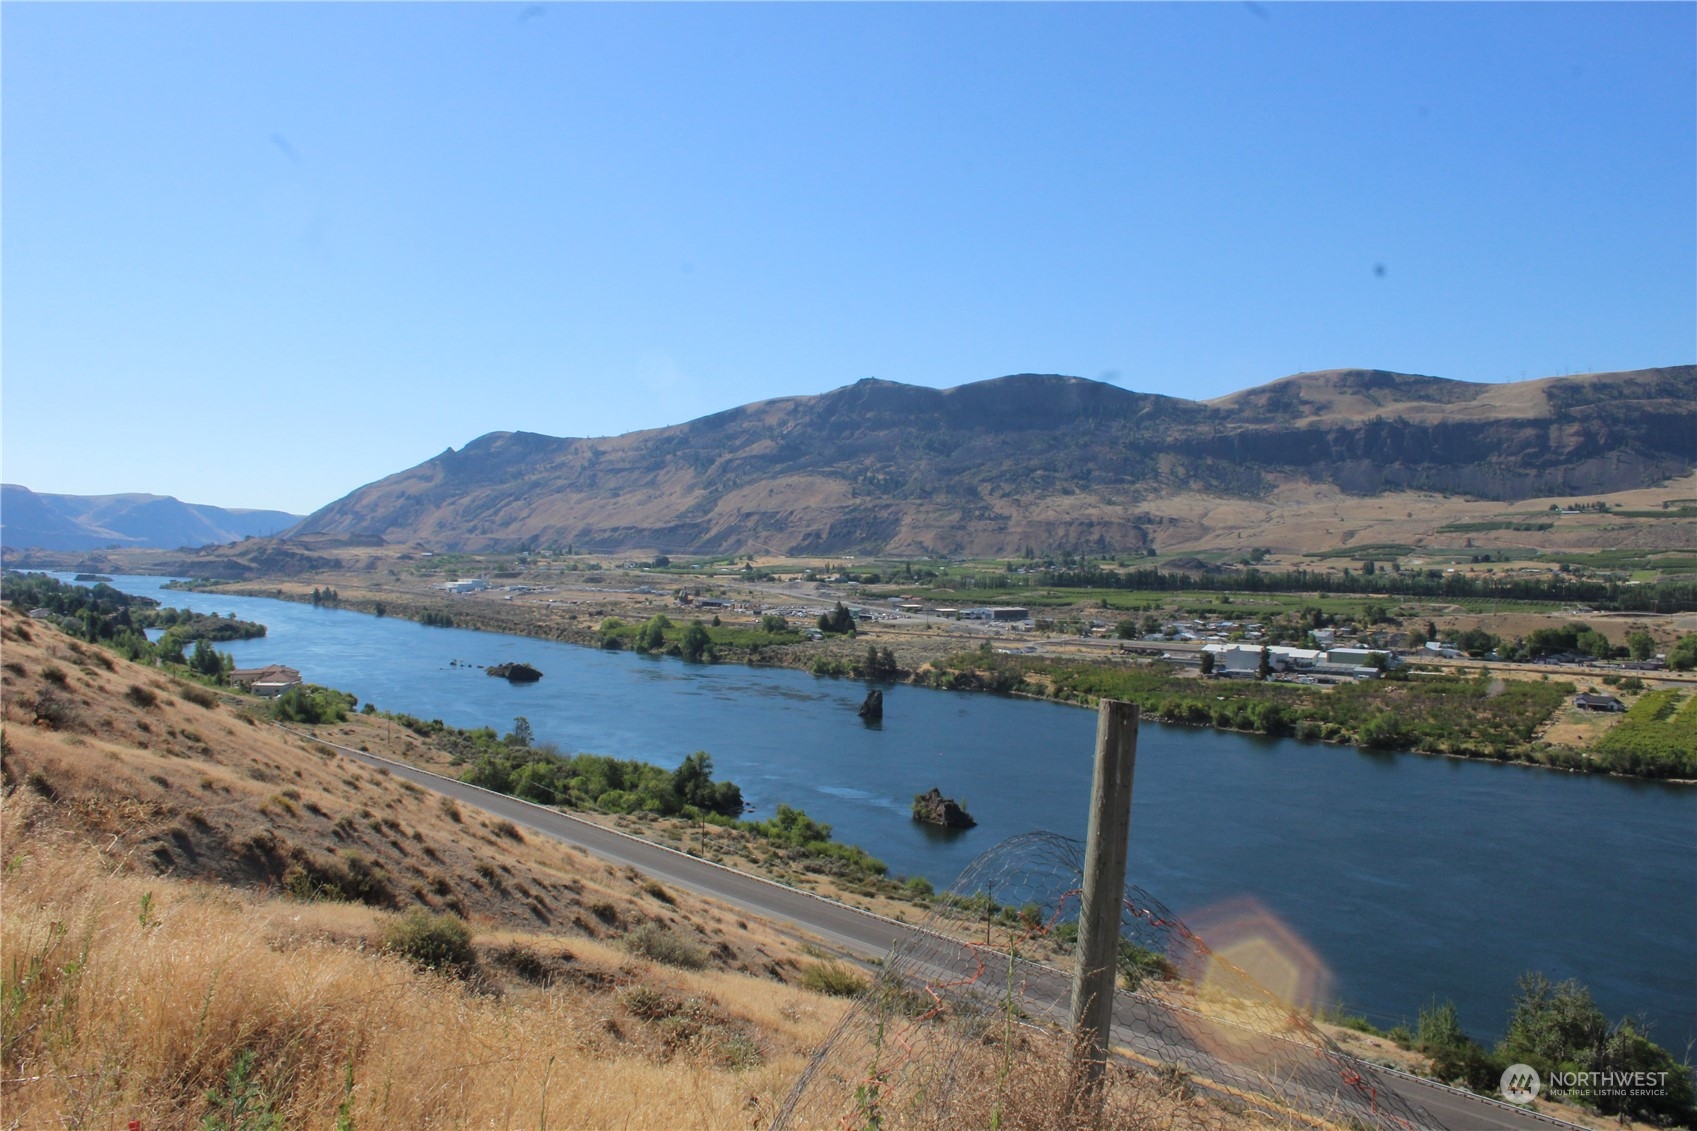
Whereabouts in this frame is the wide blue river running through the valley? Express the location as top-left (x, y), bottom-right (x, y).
top-left (82, 577), bottom-right (1697, 1055)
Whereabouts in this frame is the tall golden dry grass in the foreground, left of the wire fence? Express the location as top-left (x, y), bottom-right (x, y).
top-left (0, 788), bottom-right (840, 1128)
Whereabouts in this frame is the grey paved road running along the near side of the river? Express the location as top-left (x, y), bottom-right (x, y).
top-left (298, 735), bottom-right (1575, 1131)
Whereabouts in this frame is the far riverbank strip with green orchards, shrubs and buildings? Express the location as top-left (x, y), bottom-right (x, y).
top-left (162, 579), bottom-right (1697, 783)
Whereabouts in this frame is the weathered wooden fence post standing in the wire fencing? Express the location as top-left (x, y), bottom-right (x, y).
top-left (1073, 700), bottom-right (1139, 1102)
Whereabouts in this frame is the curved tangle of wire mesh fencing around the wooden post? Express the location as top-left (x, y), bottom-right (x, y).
top-left (772, 832), bottom-right (1441, 1131)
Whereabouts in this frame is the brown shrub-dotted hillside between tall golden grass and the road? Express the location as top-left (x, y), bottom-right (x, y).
top-left (0, 608), bottom-right (807, 976)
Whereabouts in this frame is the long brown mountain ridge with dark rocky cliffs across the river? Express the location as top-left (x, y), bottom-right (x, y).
top-left (290, 365), bottom-right (1697, 554)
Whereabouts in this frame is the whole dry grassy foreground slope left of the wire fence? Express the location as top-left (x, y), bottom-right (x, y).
top-left (0, 610), bottom-right (855, 1128)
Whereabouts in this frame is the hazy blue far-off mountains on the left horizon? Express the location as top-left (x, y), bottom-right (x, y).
top-left (0, 484), bottom-right (300, 550)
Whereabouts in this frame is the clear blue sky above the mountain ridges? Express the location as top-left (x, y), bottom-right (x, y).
top-left (0, 2), bottom-right (1697, 511)
